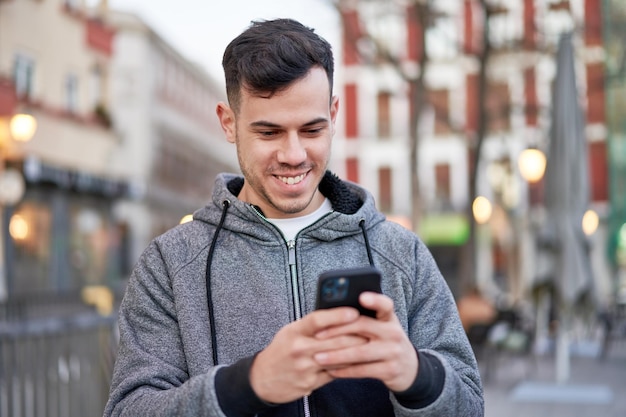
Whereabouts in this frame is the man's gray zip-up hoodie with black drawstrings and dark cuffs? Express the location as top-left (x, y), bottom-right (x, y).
top-left (104, 173), bottom-right (484, 417)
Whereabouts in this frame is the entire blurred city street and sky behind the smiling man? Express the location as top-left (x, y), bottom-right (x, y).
top-left (0, 0), bottom-right (626, 416)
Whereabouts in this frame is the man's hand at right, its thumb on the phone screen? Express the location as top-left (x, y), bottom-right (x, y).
top-left (315, 292), bottom-right (419, 392)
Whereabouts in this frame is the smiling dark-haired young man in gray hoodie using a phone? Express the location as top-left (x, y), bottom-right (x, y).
top-left (105, 19), bottom-right (483, 417)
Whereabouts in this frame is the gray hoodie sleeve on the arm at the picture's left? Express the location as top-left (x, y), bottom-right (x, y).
top-left (104, 242), bottom-right (225, 417)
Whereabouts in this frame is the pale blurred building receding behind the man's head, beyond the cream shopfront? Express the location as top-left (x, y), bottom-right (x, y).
top-left (109, 12), bottom-right (238, 259)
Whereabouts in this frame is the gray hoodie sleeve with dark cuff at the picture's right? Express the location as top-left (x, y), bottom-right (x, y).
top-left (391, 240), bottom-right (484, 417)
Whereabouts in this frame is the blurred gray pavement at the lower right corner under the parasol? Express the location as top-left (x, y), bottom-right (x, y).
top-left (483, 340), bottom-right (626, 417)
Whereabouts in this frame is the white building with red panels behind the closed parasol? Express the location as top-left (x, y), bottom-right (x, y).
top-left (339, 0), bottom-right (612, 300)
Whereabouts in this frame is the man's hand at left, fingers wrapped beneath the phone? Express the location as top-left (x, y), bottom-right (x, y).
top-left (250, 307), bottom-right (366, 404)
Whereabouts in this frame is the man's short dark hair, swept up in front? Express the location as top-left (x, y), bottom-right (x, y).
top-left (222, 19), bottom-right (334, 111)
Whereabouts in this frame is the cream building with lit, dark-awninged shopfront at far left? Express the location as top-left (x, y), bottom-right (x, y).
top-left (0, 0), bottom-right (127, 297)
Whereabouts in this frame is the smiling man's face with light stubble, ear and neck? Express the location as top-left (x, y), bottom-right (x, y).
top-left (217, 67), bottom-right (338, 218)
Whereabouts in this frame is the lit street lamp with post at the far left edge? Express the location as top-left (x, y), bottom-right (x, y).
top-left (0, 113), bottom-right (37, 302)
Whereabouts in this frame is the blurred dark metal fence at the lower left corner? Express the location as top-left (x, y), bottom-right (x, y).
top-left (0, 297), bottom-right (117, 417)
